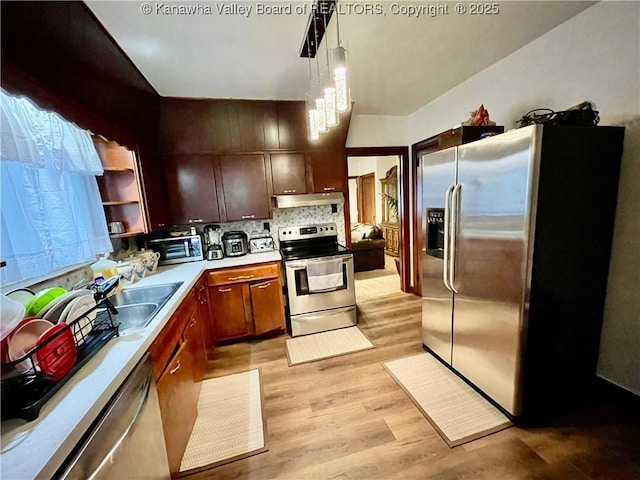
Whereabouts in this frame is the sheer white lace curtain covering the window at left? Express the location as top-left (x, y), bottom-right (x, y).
top-left (0, 91), bottom-right (112, 286)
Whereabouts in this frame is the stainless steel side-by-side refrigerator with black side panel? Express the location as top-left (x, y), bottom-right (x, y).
top-left (420, 125), bottom-right (624, 418)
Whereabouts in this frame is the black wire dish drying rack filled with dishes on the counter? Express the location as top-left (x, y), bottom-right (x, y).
top-left (0, 278), bottom-right (120, 422)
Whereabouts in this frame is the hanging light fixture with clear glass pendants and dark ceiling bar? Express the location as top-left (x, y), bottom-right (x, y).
top-left (300, 0), bottom-right (351, 141)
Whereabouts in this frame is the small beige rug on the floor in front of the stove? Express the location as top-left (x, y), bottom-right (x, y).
top-left (285, 327), bottom-right (374, 367)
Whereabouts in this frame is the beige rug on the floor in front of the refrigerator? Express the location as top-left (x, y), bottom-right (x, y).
top-left (383, 353), bottom-right (511, 447)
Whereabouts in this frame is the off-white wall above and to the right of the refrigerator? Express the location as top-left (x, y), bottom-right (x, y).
top-left (408, 1), bottom-right (640, 394)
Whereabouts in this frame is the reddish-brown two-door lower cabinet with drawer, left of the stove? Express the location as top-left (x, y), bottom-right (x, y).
top-left (207, 262), bottom-right (285, 340)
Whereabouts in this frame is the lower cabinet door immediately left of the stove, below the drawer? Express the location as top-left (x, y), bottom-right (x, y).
top-left (249, 278), bottom-right (284, 335)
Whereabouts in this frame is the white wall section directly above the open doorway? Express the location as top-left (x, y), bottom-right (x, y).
top-left (346, 113), bottom-right (408, 147)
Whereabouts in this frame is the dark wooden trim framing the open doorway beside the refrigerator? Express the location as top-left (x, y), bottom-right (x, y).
top-left (345, 146), bottom-right (413, 293)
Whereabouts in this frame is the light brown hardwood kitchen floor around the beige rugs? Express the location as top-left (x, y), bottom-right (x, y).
top-left (188, 294), bottom-right (640, 480)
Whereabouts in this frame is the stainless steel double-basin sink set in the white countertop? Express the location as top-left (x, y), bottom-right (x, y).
top-left (109, 282), bottom-right (182, 334)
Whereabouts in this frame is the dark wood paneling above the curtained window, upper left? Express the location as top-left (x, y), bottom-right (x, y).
top-left (0, 1), bottom-right (160, 149)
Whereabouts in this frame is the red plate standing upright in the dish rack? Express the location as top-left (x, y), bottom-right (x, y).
top-left (36, 322), bottom-right (76, 381)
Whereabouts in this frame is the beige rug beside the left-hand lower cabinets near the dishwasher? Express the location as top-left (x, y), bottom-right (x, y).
top-left (180, 370), bottom-right (268, 476)
